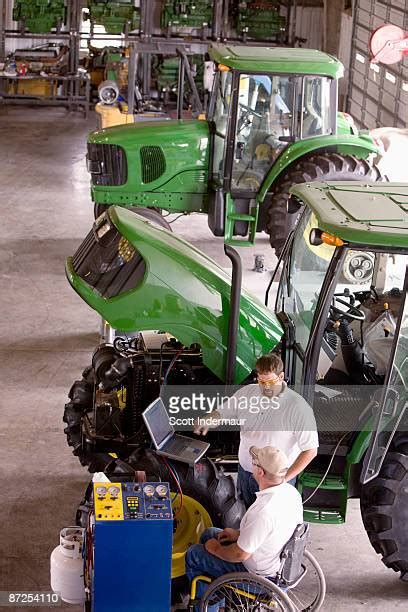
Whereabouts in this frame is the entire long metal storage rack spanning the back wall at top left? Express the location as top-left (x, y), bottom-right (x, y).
top-left (0, 0), bottom-right (301, 115)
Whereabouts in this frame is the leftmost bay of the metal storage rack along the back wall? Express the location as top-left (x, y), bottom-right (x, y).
top-left (0, 0), bottom-right (90, 117)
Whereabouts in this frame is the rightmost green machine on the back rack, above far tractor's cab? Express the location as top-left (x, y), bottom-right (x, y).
top-left (233, 0), bottom-right (286, 42)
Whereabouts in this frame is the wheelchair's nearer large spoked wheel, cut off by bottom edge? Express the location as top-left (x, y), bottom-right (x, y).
top-left (200, 572), bottom-right (296, 612)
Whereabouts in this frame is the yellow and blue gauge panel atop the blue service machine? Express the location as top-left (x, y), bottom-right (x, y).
top-left (94, 482), bottom-right (173, 521)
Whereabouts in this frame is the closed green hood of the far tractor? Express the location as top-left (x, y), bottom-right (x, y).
top-left (87, 120), bottom-right (209, 210)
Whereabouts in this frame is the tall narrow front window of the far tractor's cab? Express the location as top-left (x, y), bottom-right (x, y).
top-left (209, 72), bottom-right (232, 183)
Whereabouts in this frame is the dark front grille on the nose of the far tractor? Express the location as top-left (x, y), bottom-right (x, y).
top-left (87, 143), bottom-right (127, 186)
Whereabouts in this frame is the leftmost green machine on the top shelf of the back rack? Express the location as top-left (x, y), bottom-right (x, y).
top-left (13, 0), bottom-right (66, 34)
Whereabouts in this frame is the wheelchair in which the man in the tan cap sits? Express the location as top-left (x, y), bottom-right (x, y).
top-left (188, 523), bottom-right (326, 612)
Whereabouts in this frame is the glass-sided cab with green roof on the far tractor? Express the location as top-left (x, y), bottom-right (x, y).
top-left (208, 46), bottom-right (343, 196)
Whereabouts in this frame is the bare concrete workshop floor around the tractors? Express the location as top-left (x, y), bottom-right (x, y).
top-left (0, 107), bottom-right (408, 612)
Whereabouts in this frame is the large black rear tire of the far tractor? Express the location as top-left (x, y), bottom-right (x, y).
top-left (266, 153), bottom-right (381, 255)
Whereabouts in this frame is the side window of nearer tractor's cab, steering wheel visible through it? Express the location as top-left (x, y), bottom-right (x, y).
top-left (317, 250), bottom-right (408, 385)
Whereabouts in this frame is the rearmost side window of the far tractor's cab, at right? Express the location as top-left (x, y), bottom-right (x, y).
top-left (302, 76), bottom-right (332, 138)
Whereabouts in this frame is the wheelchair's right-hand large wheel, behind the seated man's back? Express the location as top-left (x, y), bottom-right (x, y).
top-left (286, 550), bottom-right (326, 612)
